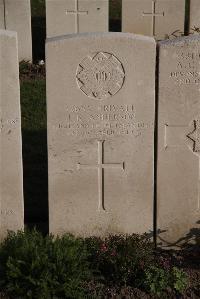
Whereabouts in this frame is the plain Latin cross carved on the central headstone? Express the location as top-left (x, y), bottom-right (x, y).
top-left (77, 141), bottom-right (125, 211)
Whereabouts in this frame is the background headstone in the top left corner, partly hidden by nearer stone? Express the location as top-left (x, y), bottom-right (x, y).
top-left (0, 0), bottom-right (32, 61)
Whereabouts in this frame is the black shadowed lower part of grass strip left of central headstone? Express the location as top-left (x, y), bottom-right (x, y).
top-left (22, 130), bottom-right (48, 233)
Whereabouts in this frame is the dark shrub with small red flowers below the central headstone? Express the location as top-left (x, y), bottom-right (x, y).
top-left (86, 235), bottom-right (153, 287)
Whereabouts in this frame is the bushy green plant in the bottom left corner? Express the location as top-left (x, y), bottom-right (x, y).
top-left (0, 230), bottom-right (91, 299)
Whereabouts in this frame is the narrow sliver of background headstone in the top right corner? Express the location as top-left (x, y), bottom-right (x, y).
top-left (189, 0), bottom-right (200, 33)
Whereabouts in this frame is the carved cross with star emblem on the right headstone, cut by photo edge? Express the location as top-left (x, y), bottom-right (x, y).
top-left (164, 120), bottom-right (200, 210)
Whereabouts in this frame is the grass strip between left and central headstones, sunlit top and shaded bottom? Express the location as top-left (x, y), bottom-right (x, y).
top-left (21, 73), bottom-right (48, 232)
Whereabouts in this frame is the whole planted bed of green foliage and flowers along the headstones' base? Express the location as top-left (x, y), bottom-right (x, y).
top-left (0, 230), bottom-right (197, 299)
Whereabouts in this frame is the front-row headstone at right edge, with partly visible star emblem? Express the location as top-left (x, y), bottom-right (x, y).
top-left (157, 36), bottom-right (200, 246)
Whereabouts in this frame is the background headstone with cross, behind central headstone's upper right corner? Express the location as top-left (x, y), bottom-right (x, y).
top-left (122, 0), bottom-right (185, 40)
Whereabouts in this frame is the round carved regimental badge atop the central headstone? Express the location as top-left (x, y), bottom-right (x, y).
top-left (76, 52), bottom-right (125, 100)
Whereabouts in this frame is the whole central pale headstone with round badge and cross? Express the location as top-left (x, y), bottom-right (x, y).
top-left (46, 33), bottom-right (156, 236)
